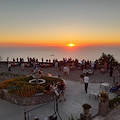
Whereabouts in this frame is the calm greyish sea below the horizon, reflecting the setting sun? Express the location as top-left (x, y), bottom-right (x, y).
top-left (0, 46), bottom-right (120, 62)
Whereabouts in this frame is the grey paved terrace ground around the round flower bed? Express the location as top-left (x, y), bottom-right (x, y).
top-left (0, 64), bottom-right (118, 120)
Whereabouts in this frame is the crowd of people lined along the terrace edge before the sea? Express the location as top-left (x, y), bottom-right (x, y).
top-left (7, 57), bottom-right (120, 78)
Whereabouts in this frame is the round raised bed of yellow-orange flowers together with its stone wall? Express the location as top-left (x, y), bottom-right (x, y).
top-left (0, 76), bottom-right (63, 105)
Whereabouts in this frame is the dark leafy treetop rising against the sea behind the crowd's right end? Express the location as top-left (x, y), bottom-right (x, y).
top-left (98, 53), bottom-right (119, 65)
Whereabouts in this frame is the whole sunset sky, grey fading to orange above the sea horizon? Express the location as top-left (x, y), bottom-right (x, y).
top-left (0, 0), bottom-right (120, 46)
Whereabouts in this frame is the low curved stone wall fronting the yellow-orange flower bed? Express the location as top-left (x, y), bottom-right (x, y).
top-left (0, 89), bottom-right (56, 106)
